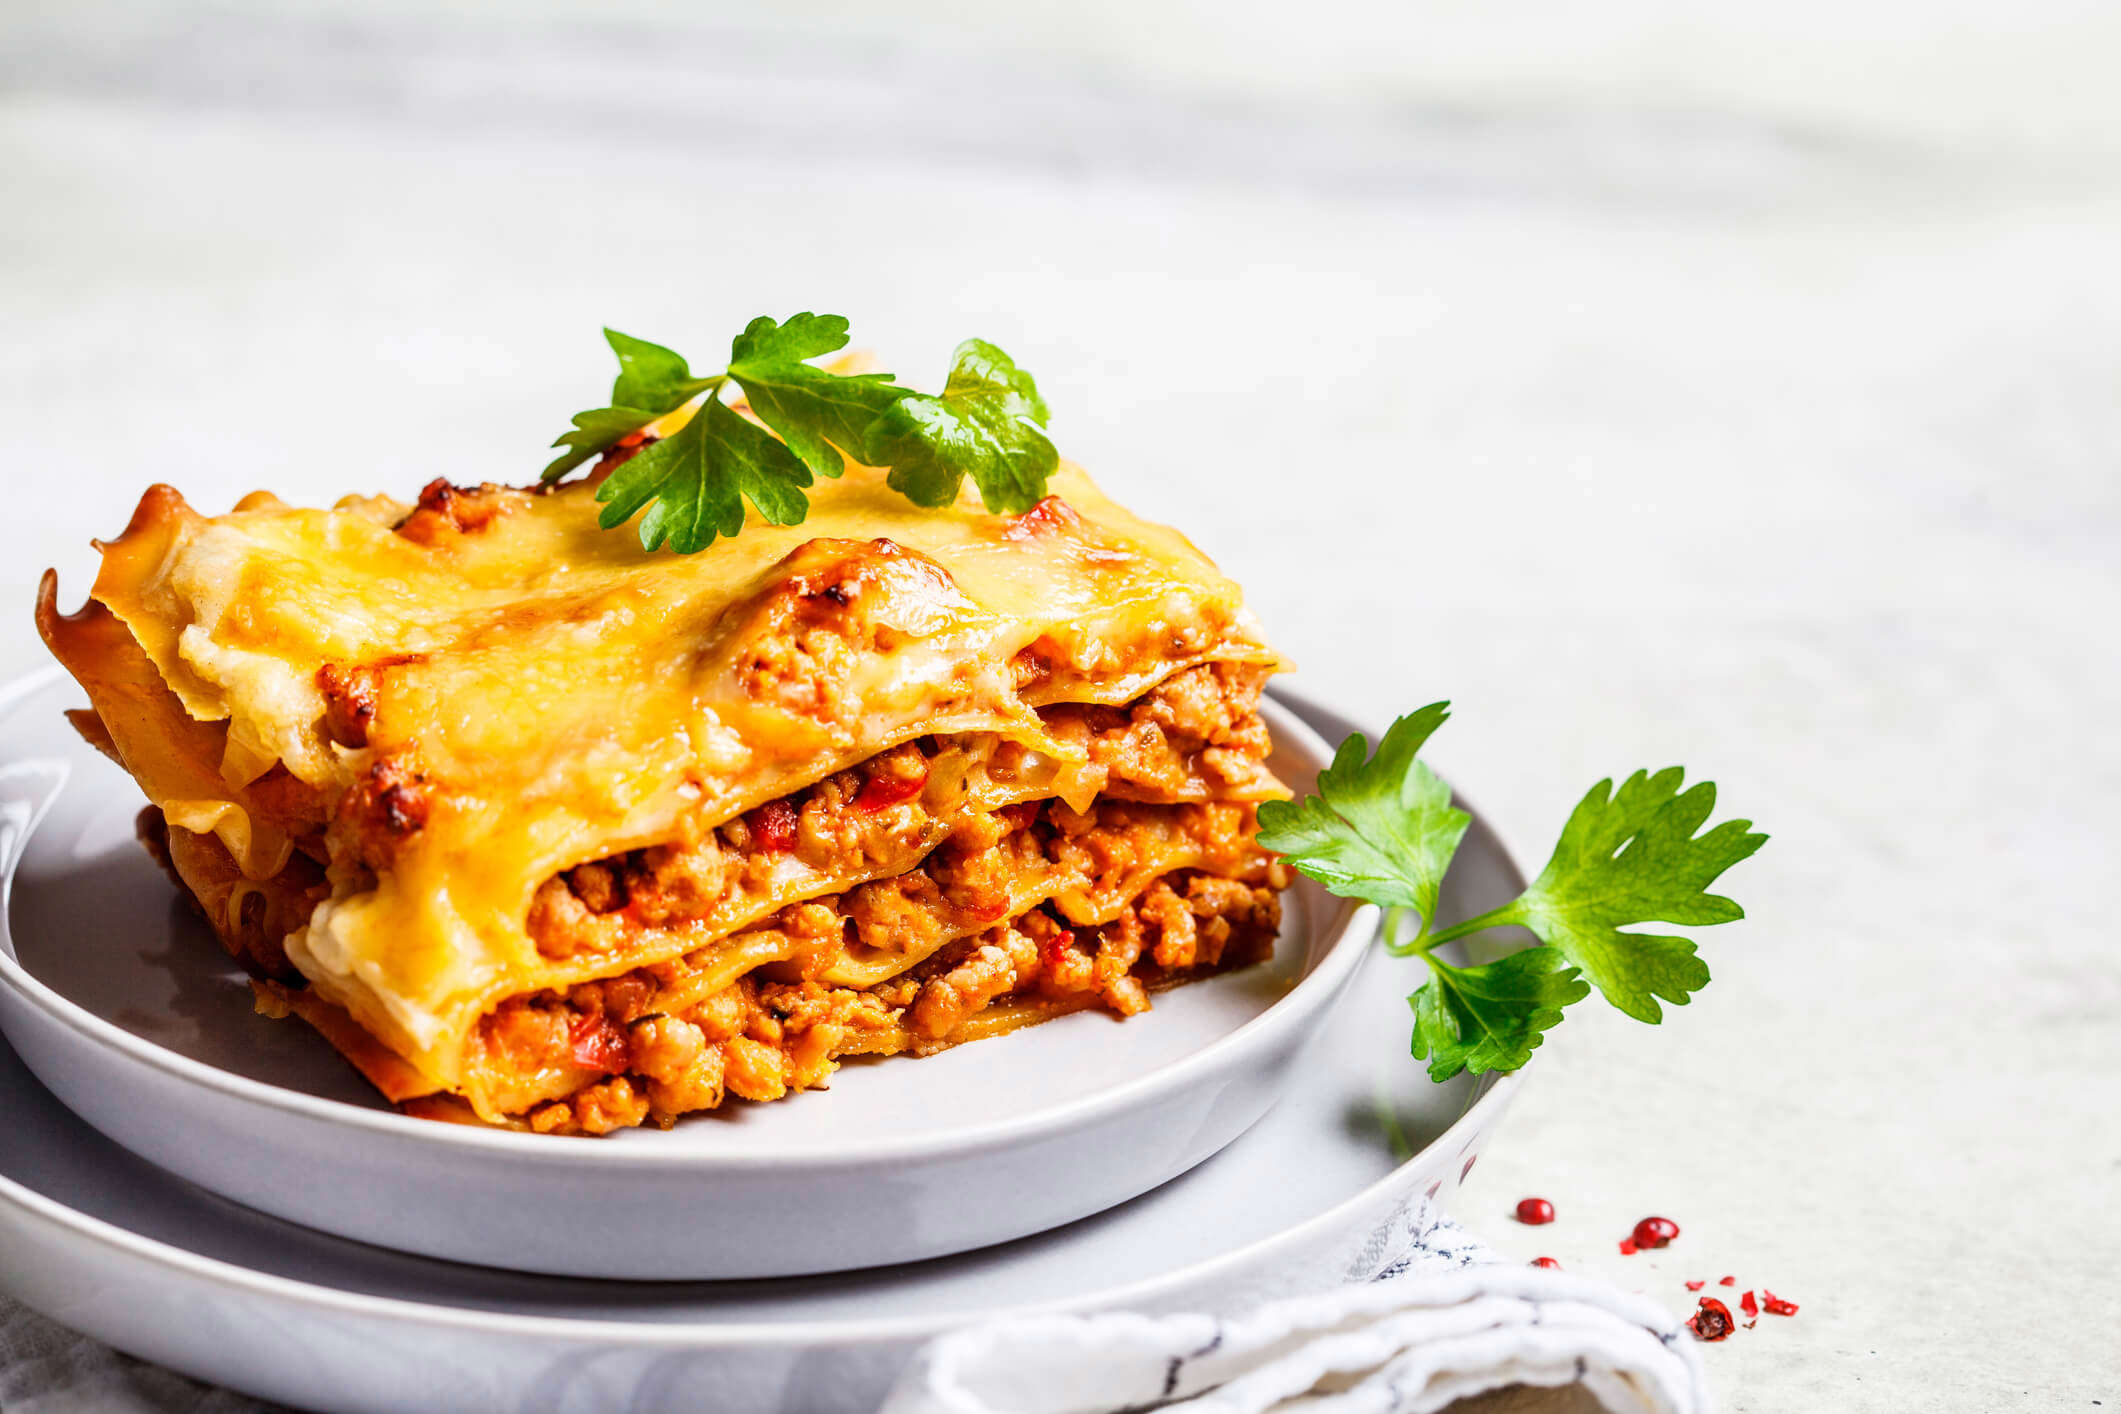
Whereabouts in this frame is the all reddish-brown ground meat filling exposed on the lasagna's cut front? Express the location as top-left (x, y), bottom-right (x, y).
top-left (473, 665), bottom-right (1287, 1134)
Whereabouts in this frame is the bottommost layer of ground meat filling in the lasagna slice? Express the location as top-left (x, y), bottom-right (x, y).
top-left (488, 865), bottom-right (1285, 1134)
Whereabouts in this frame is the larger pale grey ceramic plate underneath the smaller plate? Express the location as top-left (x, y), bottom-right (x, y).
top-left (0, 686), bottom-right (1523, 1414)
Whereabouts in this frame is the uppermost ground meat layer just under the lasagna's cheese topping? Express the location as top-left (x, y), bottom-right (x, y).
top-left (528, 664), bottom-right (1277, 958)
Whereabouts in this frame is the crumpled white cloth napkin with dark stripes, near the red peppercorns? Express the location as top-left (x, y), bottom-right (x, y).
top-left (882, 1202), bottom-right (1710, 1414)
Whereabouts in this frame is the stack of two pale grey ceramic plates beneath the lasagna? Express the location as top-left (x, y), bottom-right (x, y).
top-left (0, 674), bottom-right (1521, 1412)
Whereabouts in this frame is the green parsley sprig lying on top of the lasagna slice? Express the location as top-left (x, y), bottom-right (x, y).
top-left (545, 314), bottom-right (1061, 555)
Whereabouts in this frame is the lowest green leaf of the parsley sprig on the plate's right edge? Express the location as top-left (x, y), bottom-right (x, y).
top-left (1406, 948), bottom-right (1591, 1081)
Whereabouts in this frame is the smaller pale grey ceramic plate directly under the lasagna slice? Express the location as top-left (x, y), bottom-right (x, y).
top-left (0, 676), bottom-right (1374, 1278)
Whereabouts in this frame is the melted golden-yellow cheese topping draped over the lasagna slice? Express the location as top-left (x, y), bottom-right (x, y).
top-left (47, 466), bottom-right (1275, 1083)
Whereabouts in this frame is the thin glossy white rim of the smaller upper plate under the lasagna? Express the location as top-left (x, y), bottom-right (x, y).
top-left (0, 664), bottom-right (1374, 1174)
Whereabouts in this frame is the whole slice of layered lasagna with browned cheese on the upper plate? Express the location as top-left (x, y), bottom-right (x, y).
top-left (38, 447), bottom-right (1287, 1134)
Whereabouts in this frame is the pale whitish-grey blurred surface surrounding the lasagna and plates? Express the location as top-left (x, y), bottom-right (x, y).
top-left (0, 0), bottom-right (2121, 1410)
